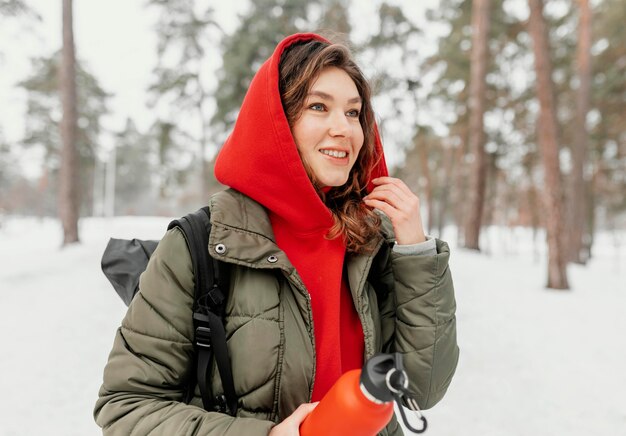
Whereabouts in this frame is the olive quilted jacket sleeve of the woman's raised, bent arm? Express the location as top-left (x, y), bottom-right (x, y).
top-left (378, 232), bottom-right (459, 409)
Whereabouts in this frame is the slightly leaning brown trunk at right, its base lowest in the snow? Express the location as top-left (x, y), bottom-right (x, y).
top-left (528, 0), bottom-right (569, 289)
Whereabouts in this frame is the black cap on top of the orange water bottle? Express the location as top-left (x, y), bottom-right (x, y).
top-left (361, 353), bottom-right (406, 403)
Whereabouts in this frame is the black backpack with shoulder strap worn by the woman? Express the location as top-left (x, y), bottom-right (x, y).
top-left (102, 207), bottom-right (237, 416)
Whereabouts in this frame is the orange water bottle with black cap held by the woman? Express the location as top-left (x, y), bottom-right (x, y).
top-left (300, 353), bottom-right (426, 436)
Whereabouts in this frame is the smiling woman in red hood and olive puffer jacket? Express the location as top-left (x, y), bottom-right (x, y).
top-left (95, 34), bottom-right (458, 436)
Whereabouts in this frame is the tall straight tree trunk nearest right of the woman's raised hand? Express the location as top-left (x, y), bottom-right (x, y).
top-left (465, 0), bottom-right (491, 250)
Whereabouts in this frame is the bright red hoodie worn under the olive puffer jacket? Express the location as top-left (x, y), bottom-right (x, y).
top-left (215, 33), bottom-right (387, 401)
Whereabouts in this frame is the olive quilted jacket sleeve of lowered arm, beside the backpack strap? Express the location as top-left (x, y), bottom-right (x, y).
top-left (94, 229), bottom-right (274, 436)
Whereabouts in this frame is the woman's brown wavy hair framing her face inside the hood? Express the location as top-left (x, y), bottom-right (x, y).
top-left (279, 40), bottom-right (381, 253)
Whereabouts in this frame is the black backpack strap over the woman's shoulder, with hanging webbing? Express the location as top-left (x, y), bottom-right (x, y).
top-left (168, 207), bottom-right (237, 416)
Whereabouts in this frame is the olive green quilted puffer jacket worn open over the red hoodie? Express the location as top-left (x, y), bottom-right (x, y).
top-left (94, 190), bottom-right (458, 436)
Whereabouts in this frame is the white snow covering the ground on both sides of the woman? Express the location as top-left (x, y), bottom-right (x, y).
top-left (0, 217), bottom-right (626, 436)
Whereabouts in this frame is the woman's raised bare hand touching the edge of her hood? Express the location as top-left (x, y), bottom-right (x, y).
top-left (363, 177), bottom-right (426, 245)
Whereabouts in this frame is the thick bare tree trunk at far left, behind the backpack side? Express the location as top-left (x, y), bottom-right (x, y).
top-left (59, 0), bottom-right (79, 245)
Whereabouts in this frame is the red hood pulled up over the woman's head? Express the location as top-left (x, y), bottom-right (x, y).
top-left (215, 33), bottom-right (387, 232)
